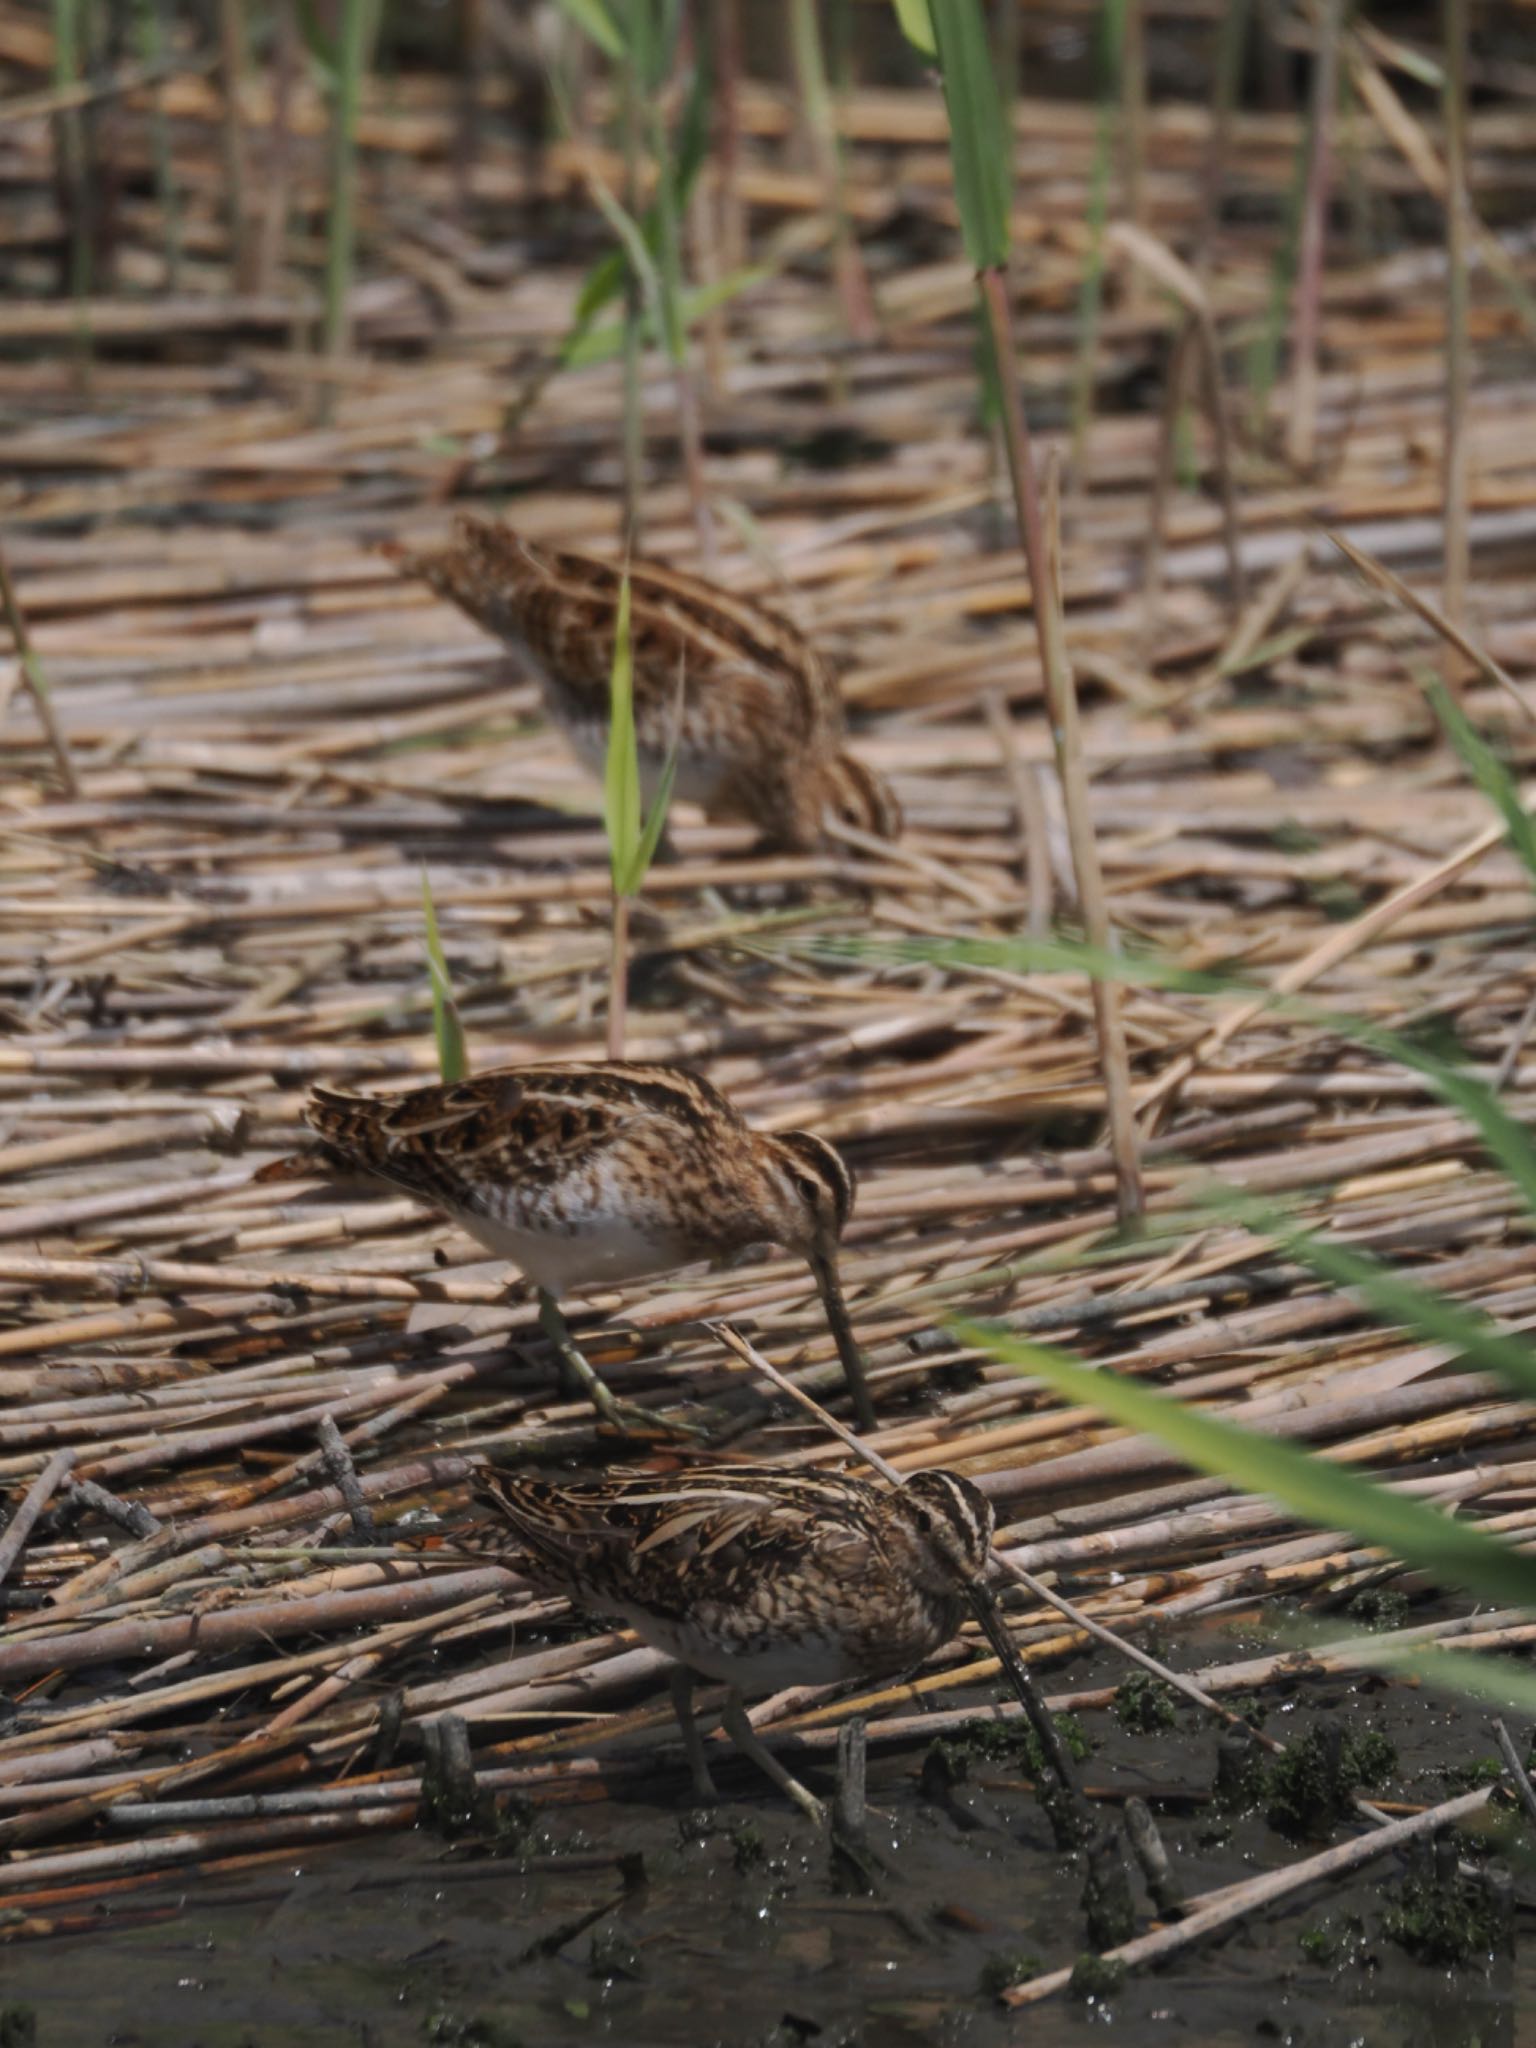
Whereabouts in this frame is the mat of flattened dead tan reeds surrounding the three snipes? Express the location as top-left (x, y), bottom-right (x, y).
top-left (0, 19), bottom-right (1536, 1966)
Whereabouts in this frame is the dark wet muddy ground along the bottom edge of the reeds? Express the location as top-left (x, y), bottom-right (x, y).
top-left (0, 1659), bottom-right (1536, 2048)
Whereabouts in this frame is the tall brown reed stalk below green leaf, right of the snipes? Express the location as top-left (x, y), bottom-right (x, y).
top-left (977, 266), bottom-right (1147, 1223)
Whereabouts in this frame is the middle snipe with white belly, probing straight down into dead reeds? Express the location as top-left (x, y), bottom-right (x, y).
top-left (290, 1061), bottom-right (874, 1430)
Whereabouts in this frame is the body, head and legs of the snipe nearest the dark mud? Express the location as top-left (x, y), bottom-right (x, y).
top-left (475, 1464), bottom-right (1012, 1821)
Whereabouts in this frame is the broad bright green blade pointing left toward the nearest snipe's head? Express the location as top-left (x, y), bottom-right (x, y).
top-left (962, 1323), bottom-right (1536, 1606)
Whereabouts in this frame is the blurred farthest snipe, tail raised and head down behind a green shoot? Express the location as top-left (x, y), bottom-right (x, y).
top-left (387, 518), bottom-right (901, 852)
